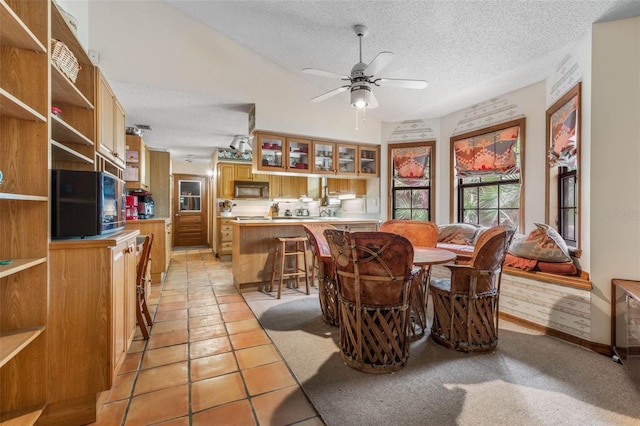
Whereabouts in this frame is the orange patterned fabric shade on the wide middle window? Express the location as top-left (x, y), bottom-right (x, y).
top-left (453, 126), bottom-right (520, 178)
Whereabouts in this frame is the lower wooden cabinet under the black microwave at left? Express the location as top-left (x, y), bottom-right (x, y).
top-left (46, 230), bottom-right (139, 424)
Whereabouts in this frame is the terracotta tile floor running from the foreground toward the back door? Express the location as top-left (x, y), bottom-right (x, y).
top-left (94, 249), bottom-right (323, 426)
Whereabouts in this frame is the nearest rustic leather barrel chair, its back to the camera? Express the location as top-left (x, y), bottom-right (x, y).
top-left (324, 230), bottom-right (413, 373)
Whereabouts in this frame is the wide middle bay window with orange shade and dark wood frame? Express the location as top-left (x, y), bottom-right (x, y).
top-left (451, 118), bottom-right (525, 228)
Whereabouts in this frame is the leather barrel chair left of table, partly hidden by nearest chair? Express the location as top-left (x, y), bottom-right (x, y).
top-left (302, 223), bottom-right (338, 326)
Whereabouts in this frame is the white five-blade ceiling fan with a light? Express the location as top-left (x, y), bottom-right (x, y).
top-left (302, 25), bottom-right (427, 108)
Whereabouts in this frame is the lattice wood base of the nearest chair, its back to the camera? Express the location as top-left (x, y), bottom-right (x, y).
top-left (339, 298), bottom-right (410, 374)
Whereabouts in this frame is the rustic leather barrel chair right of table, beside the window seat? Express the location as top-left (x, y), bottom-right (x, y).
top-left (429, 226), bottom-right (513, 352)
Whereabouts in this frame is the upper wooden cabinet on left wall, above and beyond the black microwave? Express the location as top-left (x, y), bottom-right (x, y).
top-left (95, 68), bottom-right (126, 169)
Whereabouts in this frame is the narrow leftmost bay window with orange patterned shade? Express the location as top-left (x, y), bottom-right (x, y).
top-left (389, 141), bottom-right (435, 221)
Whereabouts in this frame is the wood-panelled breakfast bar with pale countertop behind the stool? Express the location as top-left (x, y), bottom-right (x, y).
top-left (231, 217), bottom-right (380, 292)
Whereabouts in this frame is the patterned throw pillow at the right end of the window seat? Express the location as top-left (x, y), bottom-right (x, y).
top-left (508, 223), bottom-right (571, 262)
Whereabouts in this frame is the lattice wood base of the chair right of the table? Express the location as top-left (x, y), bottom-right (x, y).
top-left (431, 287), bottom-right (499, 353)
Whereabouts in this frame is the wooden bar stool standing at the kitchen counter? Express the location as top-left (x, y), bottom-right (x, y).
top-left (269, 236), bottom-right (310, 299)
